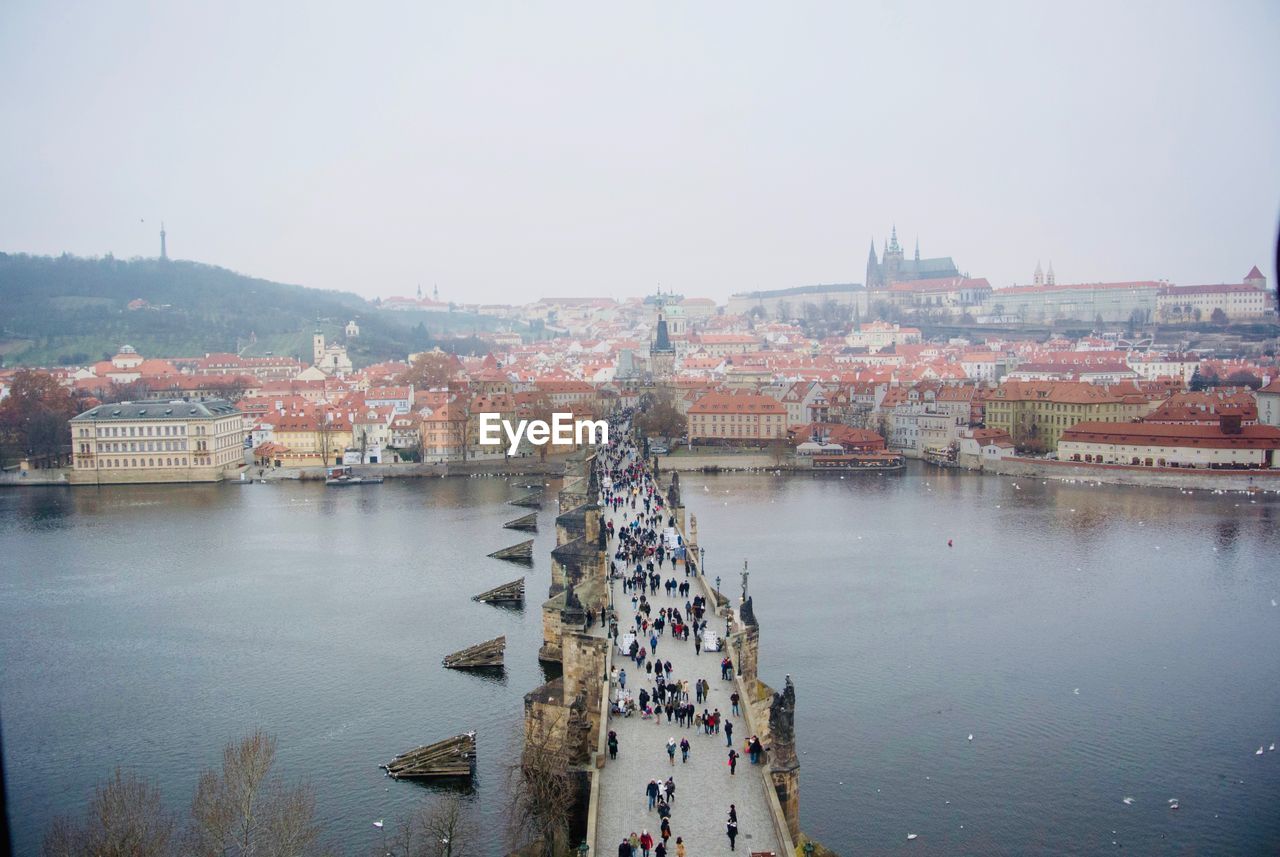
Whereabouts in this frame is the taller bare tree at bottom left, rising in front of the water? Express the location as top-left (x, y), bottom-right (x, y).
top-left (186, 730), bottom-right (320, 857)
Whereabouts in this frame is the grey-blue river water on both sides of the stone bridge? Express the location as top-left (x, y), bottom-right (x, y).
top-left (0, 464), bottom-right (1280, 854)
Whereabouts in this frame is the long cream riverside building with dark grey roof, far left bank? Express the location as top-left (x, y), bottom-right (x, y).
top-left (69, 399), bottom-right (244, 485)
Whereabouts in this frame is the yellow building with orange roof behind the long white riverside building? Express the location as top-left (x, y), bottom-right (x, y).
top-left (986, 381), bottom-right (1155, 452)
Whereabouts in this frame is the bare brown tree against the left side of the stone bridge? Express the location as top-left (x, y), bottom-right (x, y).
top-left (508, 719), bottom-right (577, 857)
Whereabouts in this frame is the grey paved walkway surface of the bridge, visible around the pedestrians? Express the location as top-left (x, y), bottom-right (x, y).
top-left (594, 447), bottom-right (790, 857)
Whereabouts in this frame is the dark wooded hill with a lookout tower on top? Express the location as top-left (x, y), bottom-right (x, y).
top-left (0, 253), bottom-right (509, 366)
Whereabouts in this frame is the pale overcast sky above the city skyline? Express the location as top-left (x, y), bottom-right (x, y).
top-left (0, 0), bottom-right (1280, 303)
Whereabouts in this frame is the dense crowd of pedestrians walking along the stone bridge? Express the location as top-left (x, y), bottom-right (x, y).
top-left (596, 425), bottom-right (764, 857)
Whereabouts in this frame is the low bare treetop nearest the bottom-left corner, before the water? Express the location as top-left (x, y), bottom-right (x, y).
top-left (41, 767), bottom-right (178, 857)
